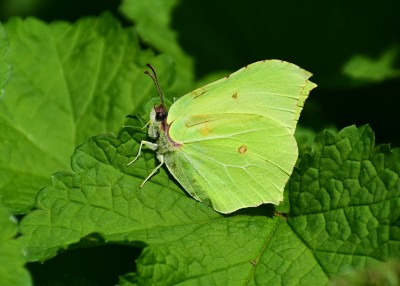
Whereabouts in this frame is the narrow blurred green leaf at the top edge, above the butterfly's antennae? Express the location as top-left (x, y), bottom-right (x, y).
top-left (120, 0), bottom-right (194, 95)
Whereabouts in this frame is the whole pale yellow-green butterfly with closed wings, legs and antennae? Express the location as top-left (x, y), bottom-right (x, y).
top-left (128, 60), bottom-right (316, 213)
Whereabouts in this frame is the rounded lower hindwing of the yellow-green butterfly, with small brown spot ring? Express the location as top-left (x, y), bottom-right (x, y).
top-left (165, 114), bottom-right (297, 213)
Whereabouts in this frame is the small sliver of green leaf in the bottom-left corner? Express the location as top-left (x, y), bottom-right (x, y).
top-left (0, 204), bottom-right (31, 286)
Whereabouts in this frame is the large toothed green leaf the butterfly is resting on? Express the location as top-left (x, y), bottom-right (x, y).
top-left (21, 123), bottom-right (400, 285)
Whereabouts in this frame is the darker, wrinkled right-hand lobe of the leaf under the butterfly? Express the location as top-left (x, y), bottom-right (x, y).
top-left (288, 126), bottom-right (400, 277)
